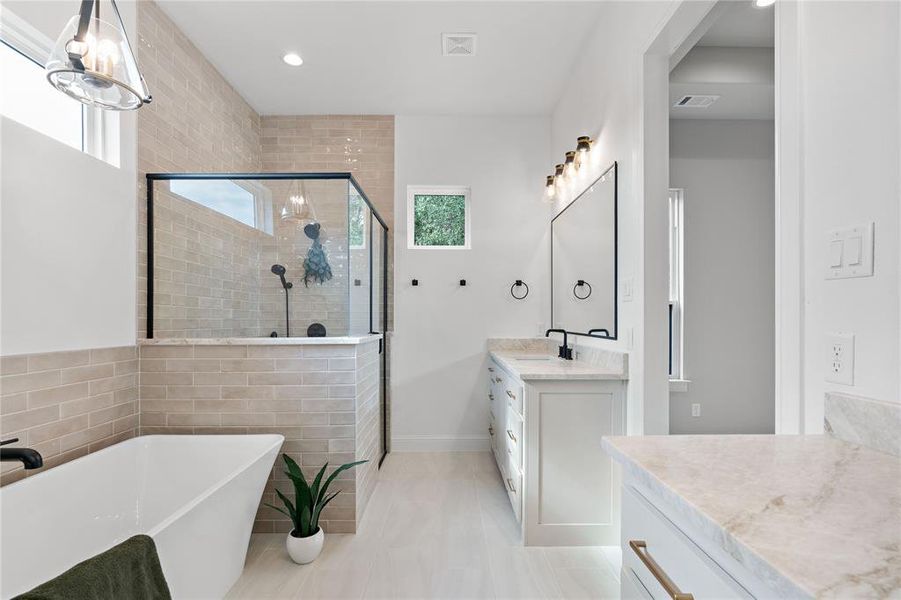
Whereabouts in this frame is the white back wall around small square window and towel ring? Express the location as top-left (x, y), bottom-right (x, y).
top-left (391, 116), bottom-right (551, 451)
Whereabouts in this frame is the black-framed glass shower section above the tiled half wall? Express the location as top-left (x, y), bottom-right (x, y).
top-left (147, 173), bottom-right (388, 338)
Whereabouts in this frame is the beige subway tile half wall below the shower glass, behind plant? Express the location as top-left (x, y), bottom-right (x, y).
top-left (140, 341), bottom-right (379, 533)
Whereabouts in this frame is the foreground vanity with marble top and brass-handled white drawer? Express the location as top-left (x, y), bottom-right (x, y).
top-left (603, 435), bottom-right (901, 599)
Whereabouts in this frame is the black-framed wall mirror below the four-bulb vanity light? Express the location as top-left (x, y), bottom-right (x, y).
top-left (551, 162), bottom-right (619, 340)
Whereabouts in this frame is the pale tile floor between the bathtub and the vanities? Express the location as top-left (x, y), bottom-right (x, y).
top-left (228, 452), bottom-right (620, 600)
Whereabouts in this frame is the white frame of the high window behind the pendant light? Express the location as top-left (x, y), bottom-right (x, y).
top-left (0, 7), bottom-right (121, 167)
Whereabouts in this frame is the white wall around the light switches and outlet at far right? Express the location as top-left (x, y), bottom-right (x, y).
top-left (798, 2), bottom-right (901, 432)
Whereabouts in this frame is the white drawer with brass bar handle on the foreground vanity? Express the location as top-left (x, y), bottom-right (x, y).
top-left (622, 486), bottom-right (752, 600)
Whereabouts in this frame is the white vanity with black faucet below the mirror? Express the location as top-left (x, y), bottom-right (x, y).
top-left (486, 340), bottom-right (627, 546)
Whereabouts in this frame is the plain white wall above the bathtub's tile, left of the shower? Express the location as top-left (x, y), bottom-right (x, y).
top-left (0, 2), bottom-right (136, 355)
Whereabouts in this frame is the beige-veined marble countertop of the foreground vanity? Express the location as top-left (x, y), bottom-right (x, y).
top-left (603, 435), bottom-right (901, 598)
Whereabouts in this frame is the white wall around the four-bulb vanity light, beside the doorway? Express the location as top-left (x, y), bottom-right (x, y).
top-left (548, 2), bottom-right (673, 434)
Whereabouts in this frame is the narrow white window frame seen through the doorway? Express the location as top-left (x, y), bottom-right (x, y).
top-left (668, 188), bottom-right (685, 381)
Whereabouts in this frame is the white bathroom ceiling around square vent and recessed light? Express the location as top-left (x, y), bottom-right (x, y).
top-left (158, 0), bottom-right (601, 115)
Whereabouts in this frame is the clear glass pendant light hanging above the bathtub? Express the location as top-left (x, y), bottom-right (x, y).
top-left (46, 0), bottom-right (151, 110)
